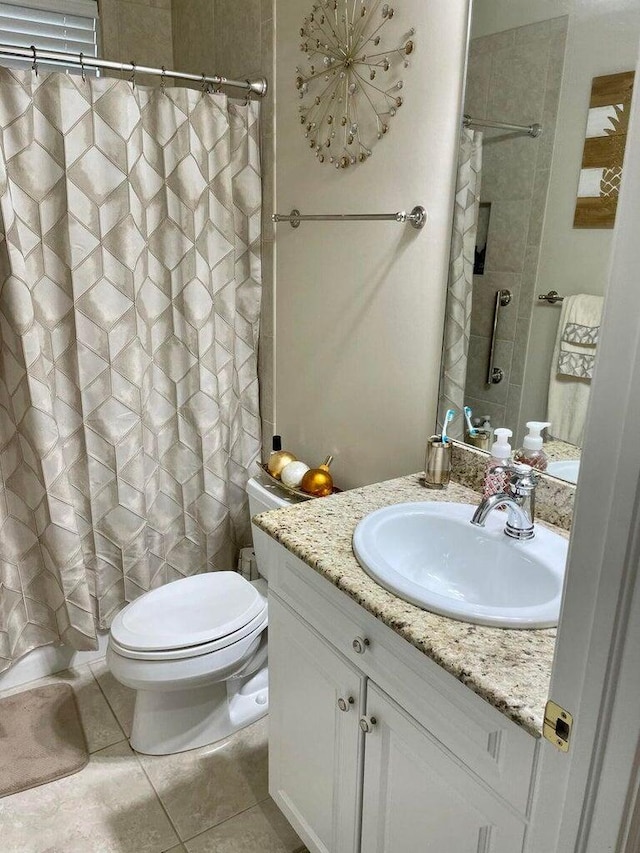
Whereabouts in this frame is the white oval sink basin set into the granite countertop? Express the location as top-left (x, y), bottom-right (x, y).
top-left (353, 501), bottom-right (568, 628)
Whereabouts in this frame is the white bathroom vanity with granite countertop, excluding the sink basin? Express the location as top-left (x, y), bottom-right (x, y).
top-left (256, 477), bottom-right (555, 853)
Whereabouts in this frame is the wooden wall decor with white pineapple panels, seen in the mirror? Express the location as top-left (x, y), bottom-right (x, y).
top-left (573, 71), bottom-right (634, 228)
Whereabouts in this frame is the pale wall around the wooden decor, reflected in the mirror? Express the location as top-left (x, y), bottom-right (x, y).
top-left (521, 0), bottom-right (640, 422)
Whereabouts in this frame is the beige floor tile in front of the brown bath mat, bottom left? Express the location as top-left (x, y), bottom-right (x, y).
top-left (0, 741), bottom-right (179, 853)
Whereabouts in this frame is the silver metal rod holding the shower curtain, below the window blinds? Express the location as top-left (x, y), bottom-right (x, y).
top-left (0, 44), bottom-right (268, 98)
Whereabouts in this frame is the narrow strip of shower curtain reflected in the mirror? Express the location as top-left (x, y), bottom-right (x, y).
top-left (438, 128), bottom-right (482, 438)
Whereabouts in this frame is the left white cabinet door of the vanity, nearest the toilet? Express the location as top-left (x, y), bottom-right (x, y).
top-left (269, 593), bottom-right (365, 853)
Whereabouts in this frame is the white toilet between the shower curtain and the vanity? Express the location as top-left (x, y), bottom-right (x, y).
top-left (107, 479), bottom-right (297, 755)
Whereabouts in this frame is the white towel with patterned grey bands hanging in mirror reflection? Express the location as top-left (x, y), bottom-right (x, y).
top-left (547, 293), bottom-right (604, 445)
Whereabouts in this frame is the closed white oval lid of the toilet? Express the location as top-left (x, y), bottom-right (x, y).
top-left (111, 572), bottom-right (266, 651)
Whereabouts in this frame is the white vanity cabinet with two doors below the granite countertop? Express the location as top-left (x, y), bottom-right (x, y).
top-left (269, 542), bottom-right (538, 853)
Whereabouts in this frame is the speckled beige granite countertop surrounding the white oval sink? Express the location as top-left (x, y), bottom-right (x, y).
top-left (254, 475), bottom-right (568, 737)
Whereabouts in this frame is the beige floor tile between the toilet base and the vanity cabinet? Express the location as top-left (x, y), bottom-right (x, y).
top-left (138, 720), bottom-right (268, 841)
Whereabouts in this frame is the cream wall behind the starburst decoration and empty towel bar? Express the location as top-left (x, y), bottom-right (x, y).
top-left (275, 0), bottom-right (468, 488)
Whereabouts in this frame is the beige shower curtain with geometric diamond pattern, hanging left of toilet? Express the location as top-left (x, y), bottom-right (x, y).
top-left (0, 69), bottom-right (261, 669)
